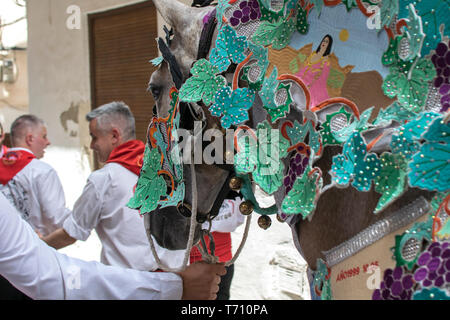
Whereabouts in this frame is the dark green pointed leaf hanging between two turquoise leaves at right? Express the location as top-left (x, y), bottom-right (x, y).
top-left (374, 153), bottom-right (408, 214)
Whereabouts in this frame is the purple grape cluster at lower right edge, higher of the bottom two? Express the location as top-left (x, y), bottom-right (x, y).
top-left (414, 242), bottom-right (450, 288)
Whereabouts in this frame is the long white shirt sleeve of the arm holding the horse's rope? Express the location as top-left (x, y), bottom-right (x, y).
top-left (0, 194), bottom-right (183, 300)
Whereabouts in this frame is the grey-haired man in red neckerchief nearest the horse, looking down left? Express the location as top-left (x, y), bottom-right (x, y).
top-left (43, 102), bottom-right (178, 271)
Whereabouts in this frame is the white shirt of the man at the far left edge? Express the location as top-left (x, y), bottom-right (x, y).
top-left (0, 148), bottom-right (70, 236)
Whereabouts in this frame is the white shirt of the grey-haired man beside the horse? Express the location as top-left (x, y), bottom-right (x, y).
top-left (63, 163), bottom-right (157, 271)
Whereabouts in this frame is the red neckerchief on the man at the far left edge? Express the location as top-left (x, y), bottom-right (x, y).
top-left (0, 150), bottom-right (36, 185)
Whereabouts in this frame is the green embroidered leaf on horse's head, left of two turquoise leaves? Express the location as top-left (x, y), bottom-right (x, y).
top-left (179, 59), bottom-right (226, 106)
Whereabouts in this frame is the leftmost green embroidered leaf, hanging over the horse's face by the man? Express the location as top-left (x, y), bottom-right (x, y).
top-left (127, 146), bottom-right (167, 214)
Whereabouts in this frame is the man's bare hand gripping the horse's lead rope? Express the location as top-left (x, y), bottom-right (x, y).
top-left (179, 262), bottom-right (227, 300)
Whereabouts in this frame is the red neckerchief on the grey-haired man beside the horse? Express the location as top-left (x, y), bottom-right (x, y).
top-left (106, 140), bottom-right (145, 175)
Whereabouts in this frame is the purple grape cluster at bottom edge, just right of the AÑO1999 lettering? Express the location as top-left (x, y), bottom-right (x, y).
top-left (372, 267), bottom-right (415, 300)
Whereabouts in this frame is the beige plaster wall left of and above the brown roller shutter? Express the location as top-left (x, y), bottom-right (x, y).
top-left (27, 0), bottom-right (156, 261)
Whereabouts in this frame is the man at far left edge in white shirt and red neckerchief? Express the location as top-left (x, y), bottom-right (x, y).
top-left (0, 115), bottom-right (70, 236)
